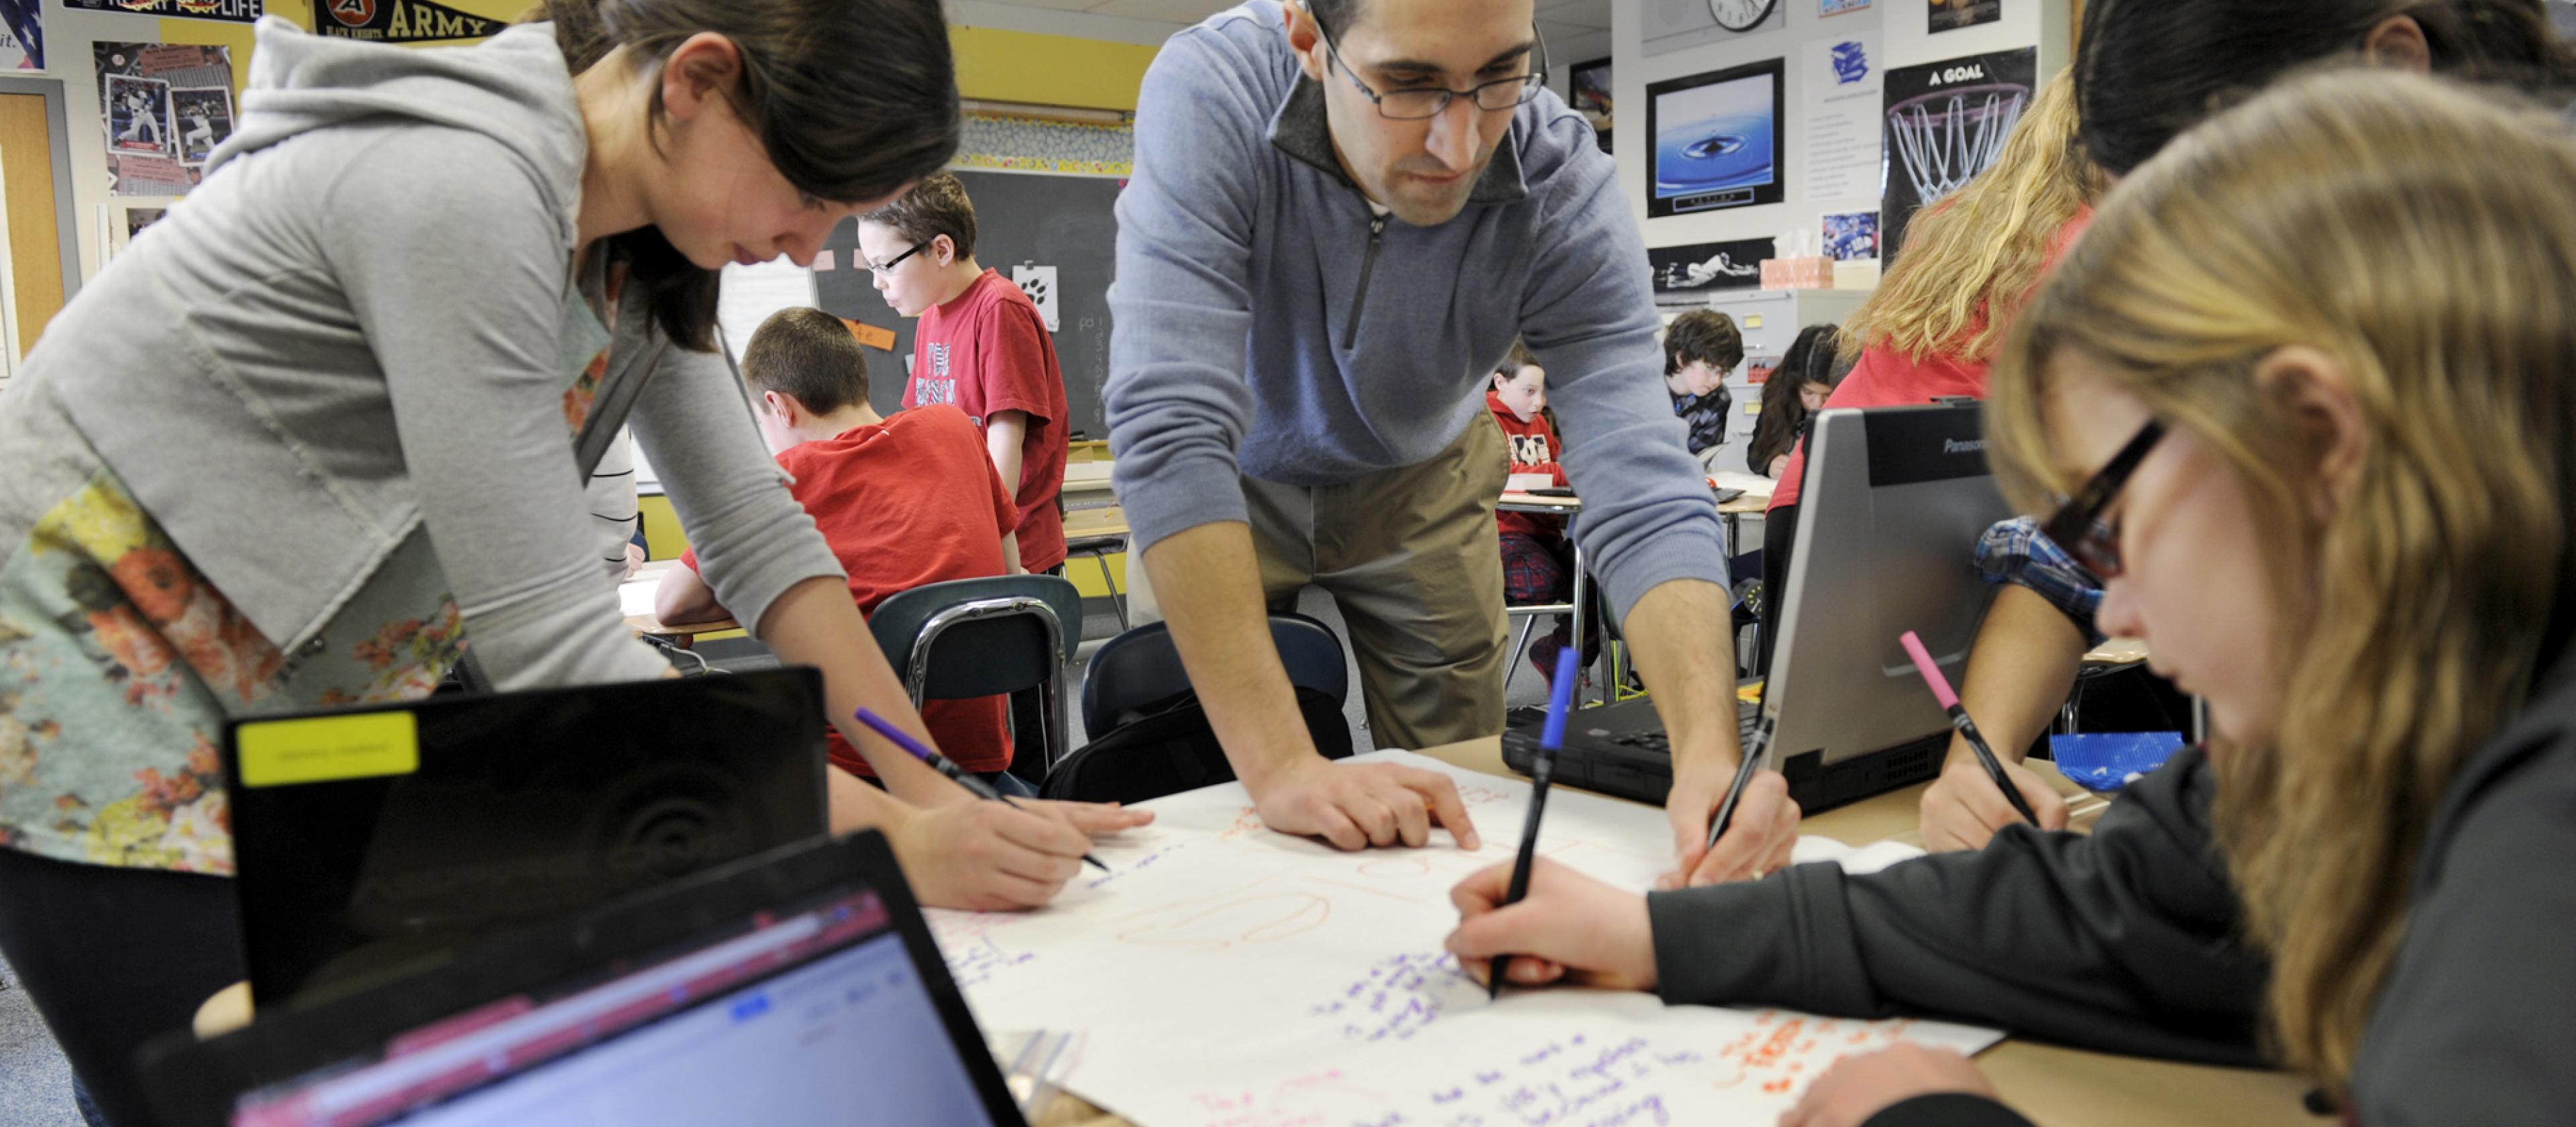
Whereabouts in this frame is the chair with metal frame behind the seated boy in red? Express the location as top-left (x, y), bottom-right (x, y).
top-left (868, 576), bottom-right (1082, 777)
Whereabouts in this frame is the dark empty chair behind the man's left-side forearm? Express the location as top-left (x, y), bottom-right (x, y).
top-left (1040, 615), bottom-right (1352, 803)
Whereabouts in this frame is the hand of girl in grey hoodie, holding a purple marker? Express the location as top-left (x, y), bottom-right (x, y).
top-left (886, 803), bottom-right (1092, 911)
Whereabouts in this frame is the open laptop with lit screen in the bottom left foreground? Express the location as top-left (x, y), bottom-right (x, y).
top-left (142, 834), bottom-right (1022, 1127)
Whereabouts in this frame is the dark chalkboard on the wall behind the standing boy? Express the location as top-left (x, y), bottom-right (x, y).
top-left (814, 172), bottom-right (1126, 437)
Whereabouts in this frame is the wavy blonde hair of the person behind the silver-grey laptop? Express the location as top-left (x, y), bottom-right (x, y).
top-left (1834, 72), bottom-right (2094, 360)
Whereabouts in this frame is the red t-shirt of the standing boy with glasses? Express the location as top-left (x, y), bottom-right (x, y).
top-left (904, 270), bottom-right (1067, 572)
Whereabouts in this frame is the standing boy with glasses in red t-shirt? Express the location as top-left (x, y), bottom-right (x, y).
top-left (858, 172), bottom-right (1067, 574)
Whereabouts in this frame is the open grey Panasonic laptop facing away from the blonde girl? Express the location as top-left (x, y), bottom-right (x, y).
top-left (1502, 404), bottom-right (2012, 813)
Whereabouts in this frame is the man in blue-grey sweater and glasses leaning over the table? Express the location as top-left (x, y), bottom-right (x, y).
top-left (1105, 0), bottom-right (1798, 883)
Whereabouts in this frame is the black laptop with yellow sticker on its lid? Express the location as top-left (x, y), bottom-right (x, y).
top-left (224, 669), bottom-right (829, 1004)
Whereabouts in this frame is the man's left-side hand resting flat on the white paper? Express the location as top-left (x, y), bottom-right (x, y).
top-left (1244, 754), bottom-right (1484, 852)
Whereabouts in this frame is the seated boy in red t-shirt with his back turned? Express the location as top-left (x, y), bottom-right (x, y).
top-left (654, 309), bottom-right (1020, 777)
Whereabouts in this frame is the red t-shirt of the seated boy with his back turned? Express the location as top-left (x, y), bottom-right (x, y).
top-left (680, 407), bottom-right (1020, 775)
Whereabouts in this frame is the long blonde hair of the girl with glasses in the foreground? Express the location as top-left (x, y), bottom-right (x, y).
top-left (1986, 72), bottom-right (2576, 1091)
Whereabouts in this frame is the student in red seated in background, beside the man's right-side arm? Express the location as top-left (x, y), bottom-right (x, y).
top-left (1484, 342), bottom-right (1600, 680)
